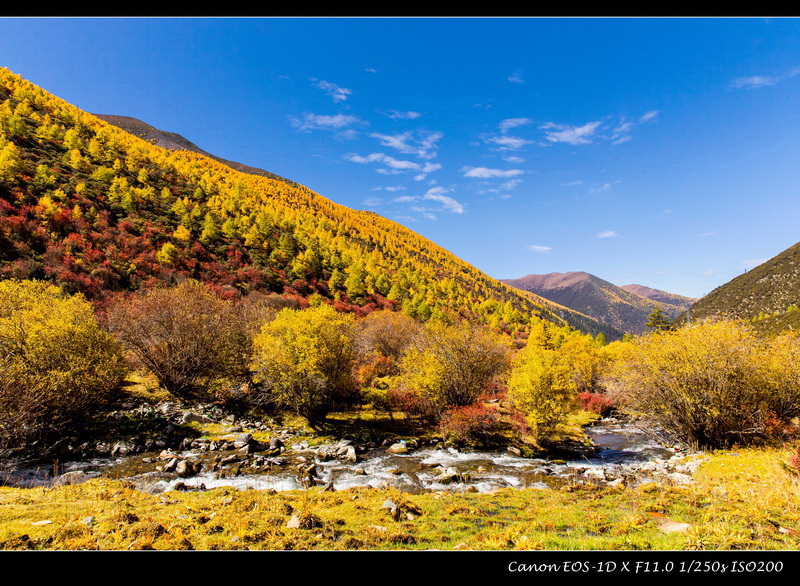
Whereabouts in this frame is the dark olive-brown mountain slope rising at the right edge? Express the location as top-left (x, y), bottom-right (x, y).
top-left (677, 242), bottom-right (800, 332)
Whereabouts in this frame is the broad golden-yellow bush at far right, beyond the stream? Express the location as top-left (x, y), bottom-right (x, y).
top-left (609, 321), bottom-right (800, 448)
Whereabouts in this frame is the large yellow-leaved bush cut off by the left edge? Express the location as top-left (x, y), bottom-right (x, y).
top-left (0, 281), bottom-right (126, 447)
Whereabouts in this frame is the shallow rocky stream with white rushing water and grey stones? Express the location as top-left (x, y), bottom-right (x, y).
top-left (0, 410), bottom-right (700, 493)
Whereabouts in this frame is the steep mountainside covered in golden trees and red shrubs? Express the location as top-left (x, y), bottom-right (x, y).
top-left (0, 69), bottom-right (619, 339)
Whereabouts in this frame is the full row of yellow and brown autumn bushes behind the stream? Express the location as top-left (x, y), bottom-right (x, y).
top-left (0, 280), bottom-right (800, 447)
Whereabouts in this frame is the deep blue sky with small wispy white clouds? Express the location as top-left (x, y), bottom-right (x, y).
top-left (0, 18), bottom-right (800, 297)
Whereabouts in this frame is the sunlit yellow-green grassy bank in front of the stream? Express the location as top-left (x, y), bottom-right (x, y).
top-left (0, 448), bottom-right (800, 550)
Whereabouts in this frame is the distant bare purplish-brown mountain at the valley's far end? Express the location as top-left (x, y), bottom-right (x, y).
top-left (501, 272), bottom-right (693, 334)
